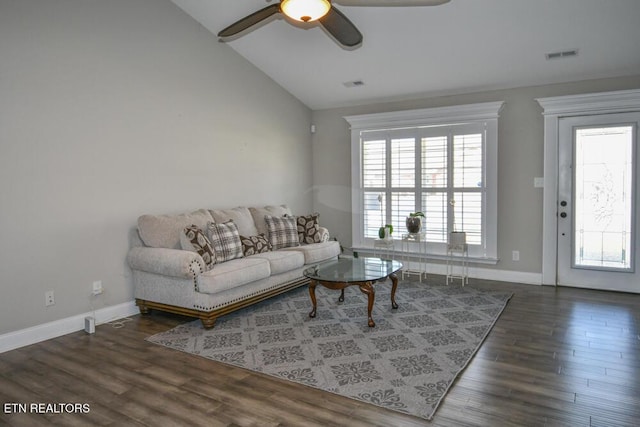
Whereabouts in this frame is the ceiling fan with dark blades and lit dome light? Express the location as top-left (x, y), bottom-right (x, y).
top-left (218, 0), bottom-right (450, 47)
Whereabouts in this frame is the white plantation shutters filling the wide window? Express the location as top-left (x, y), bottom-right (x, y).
top-left (362, 126), bottom-right (484, 245)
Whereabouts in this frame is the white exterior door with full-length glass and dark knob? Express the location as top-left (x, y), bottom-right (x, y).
top-left (557, 113), bottom-right (640, 293)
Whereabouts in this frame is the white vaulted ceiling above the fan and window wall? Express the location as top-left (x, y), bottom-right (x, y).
top-left (172, 0), bottom-right (640, 110)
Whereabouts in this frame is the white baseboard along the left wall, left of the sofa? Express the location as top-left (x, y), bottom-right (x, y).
top-left (0, 301), bottom-right (139, 353)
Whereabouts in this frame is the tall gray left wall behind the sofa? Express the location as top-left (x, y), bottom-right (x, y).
top-left (0, 0), bottom-right (312, 334)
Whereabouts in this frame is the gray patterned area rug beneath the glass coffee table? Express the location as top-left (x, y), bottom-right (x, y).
top-left (148, 281), bottom-right (511, 419)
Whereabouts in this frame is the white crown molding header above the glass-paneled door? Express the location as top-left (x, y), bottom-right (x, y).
top-left (536, 89), bottom-right (640, 117)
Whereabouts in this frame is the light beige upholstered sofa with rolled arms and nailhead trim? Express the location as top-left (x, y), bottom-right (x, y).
top-left (127, 205), bottom-right (340, 329)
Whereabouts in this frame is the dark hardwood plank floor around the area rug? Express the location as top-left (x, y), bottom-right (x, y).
top-left (0, 278), bottom-right (640, 427)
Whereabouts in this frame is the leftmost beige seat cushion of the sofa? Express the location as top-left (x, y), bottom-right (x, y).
top-left (198, 257), bottom-right (271, 293)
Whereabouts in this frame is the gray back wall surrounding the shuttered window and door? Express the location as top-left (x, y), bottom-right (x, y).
top-left (312, 76), bottom-right (640, 273)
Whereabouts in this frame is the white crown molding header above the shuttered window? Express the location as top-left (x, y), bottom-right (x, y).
top-left (344, 101), bottom-right (504, 130)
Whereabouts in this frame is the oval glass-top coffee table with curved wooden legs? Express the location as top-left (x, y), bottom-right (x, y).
top-left (303, 258), bottom-right (402, 328)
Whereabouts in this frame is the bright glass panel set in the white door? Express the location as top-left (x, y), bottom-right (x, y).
top-left (572, 126), bottom-right (634, 270)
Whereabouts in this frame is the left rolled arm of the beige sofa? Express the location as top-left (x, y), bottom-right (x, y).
top-left (127, 247), bottom-right (205, 278)
